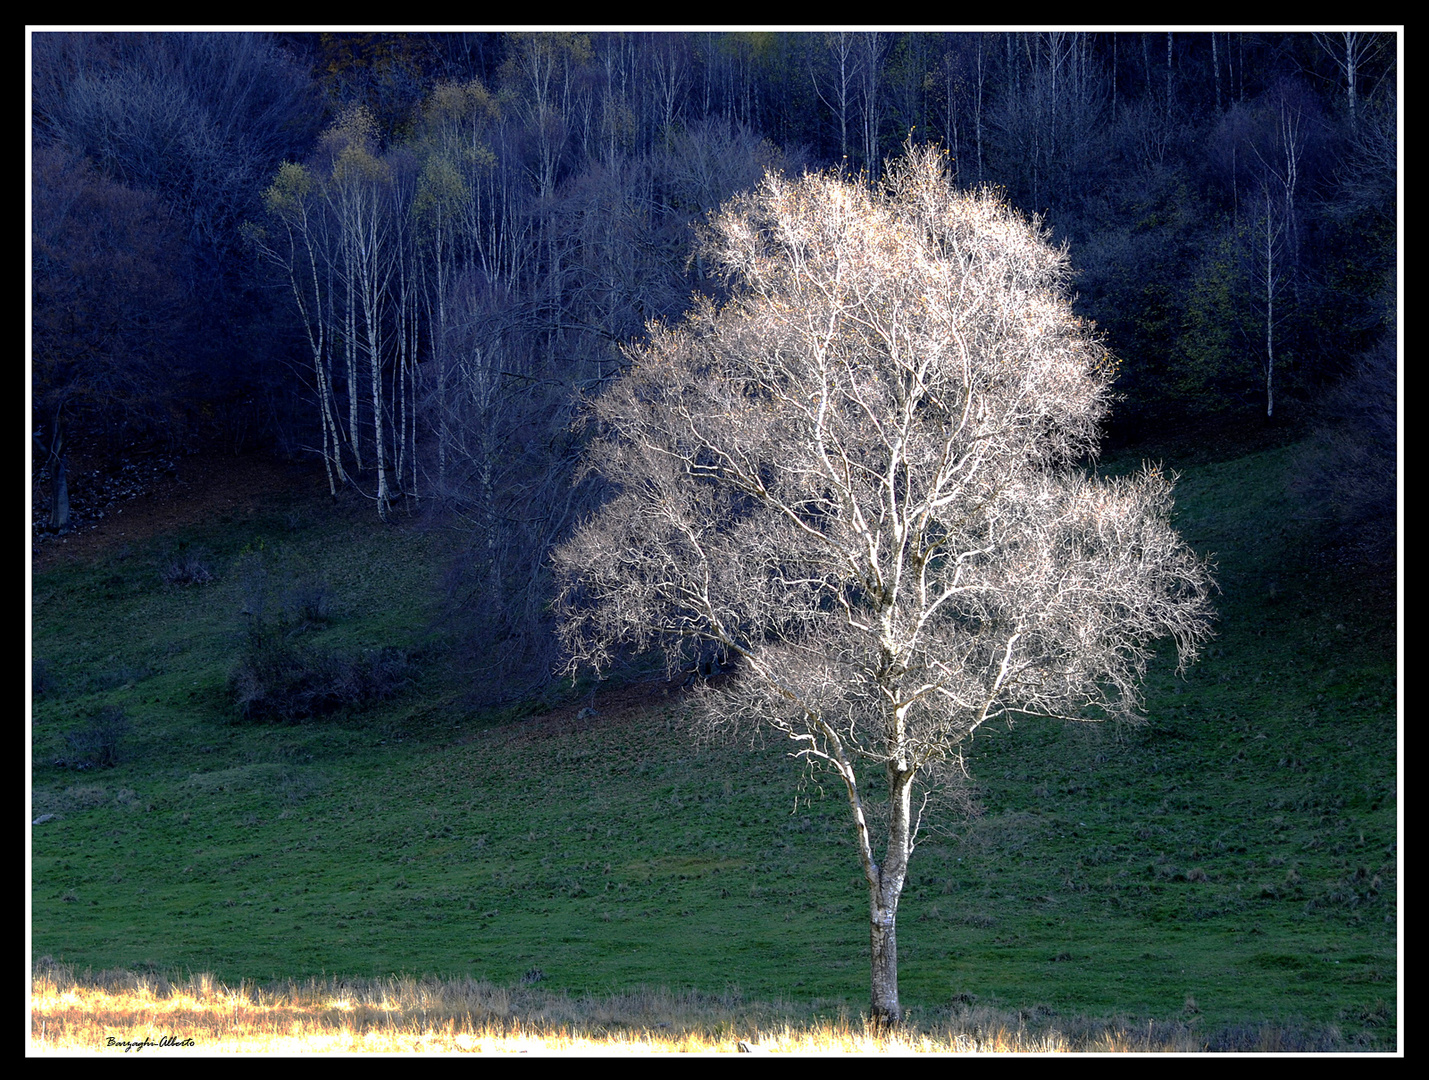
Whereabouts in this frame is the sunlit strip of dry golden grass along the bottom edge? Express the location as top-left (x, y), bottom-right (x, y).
top-left (30, 966), bottom-right (1199, 1054)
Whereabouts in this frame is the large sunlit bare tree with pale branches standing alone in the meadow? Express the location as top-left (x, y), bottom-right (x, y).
top-left (556, 150), bottom-right (1212, 1023)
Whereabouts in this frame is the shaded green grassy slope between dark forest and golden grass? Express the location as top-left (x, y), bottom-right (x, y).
top-left (31, 437), bottom-right (1398, 1049)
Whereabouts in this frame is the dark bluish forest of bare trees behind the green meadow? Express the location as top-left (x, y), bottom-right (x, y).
top-left (30, 31), bottom-right (1399, 696)
